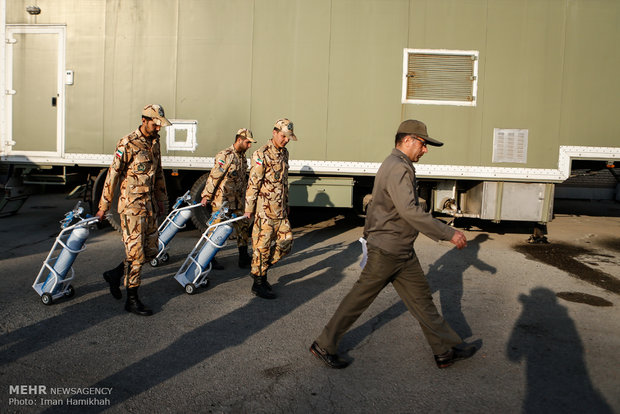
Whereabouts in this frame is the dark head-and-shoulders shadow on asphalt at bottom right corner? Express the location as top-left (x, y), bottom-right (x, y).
top-left (506, 288), bottom-right (612, 413)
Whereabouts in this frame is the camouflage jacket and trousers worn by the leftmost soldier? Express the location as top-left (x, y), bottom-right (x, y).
top-left (99, 128), bottom-right (167, 288)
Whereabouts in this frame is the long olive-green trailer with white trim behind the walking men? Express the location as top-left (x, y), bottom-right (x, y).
top-left (0, 0), bottom-right (620, 223)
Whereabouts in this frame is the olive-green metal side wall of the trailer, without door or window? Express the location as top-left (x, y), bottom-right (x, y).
top-left (7, 0), bottom-right (620, 168)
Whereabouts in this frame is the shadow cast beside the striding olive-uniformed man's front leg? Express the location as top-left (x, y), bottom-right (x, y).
top-left (427, 233), bottom-right (497, 338)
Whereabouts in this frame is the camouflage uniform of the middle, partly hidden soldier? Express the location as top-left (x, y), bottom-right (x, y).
top-left (200, 145), bottom-right (250, 247)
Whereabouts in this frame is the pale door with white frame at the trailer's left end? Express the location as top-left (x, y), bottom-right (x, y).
top-left (5, 25), bottom-right (65, 156)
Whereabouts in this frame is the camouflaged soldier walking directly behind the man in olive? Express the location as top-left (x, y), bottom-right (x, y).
top-left (245, 118), bottom-right (297, 299)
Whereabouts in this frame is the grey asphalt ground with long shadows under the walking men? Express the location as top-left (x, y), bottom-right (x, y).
top-left (0, 194), bottom-right (620, 413)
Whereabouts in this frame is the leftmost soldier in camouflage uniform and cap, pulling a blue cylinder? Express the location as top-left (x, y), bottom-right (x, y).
top-left (97, 105), bottom-right (171, 316)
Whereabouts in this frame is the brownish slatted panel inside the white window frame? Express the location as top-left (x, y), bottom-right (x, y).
top-left (407, 53), bottom-right (475, 102)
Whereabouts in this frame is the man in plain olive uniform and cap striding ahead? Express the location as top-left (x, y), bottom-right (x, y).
top-left (310, 119), bottom-right (476, 368)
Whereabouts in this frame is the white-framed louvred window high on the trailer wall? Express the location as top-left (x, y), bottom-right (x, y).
top-left (402, 49), bottom-right (478, 106)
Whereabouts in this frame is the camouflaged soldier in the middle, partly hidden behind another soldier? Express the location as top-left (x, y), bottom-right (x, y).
top-left (201, 128), bottom-right (256, 269)
